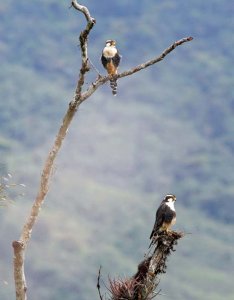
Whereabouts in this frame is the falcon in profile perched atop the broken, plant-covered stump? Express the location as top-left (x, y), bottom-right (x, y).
top-left (150, 195), bottom-right (176, 246)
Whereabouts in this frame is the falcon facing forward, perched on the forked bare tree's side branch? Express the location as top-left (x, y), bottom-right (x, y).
top-left (101, 40), bottom-right (121, 96)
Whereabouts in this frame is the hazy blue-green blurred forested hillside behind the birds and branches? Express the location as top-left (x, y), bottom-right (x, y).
top-left (0, 0), bottom-right (234, 300)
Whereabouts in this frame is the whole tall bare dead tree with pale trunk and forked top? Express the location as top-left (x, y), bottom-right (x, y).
top-left (12, 0), bottom-right (192, 300)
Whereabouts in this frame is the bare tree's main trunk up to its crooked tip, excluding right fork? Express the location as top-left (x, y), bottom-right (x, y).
top-left (12, 1), bottom-right (95, 300)
